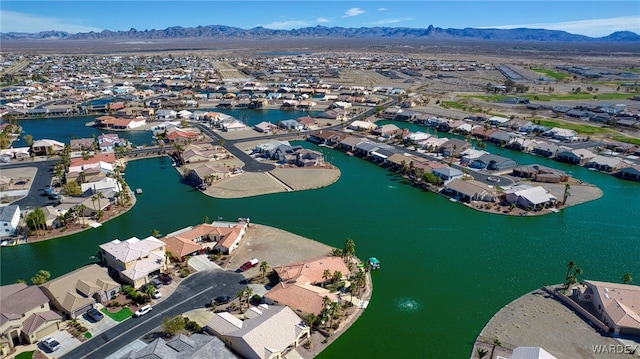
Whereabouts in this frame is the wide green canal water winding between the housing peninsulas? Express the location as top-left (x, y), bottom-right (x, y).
top-left (0, 131), bottom-right (640, 358)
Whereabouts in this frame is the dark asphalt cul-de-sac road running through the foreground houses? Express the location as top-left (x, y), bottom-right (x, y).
top-left (61, 270), bottom-right (246, 359)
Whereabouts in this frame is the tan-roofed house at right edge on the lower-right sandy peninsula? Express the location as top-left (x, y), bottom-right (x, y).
top-left (574, 280), bottom-right (640, 337)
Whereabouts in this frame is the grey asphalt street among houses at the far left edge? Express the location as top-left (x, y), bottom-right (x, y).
top-left (0, 160), bottom-right (58, 210)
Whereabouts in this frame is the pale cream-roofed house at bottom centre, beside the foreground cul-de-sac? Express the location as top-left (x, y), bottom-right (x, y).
top-left (206, 304), bottom-right (311, 359)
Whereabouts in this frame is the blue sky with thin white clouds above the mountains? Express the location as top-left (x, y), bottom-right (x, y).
top-left (0, 0), bottom-right (640, 37)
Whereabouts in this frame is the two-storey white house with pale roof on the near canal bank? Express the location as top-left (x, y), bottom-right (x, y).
top-left (100, 236), bottom-right (166, 288)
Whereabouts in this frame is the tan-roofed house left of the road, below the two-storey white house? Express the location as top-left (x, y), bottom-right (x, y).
top-left (40, 264), bottom-right (120, 318)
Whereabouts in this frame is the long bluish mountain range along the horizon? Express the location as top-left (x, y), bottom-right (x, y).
top-left (0, 25), bottom-right (640, 43)
